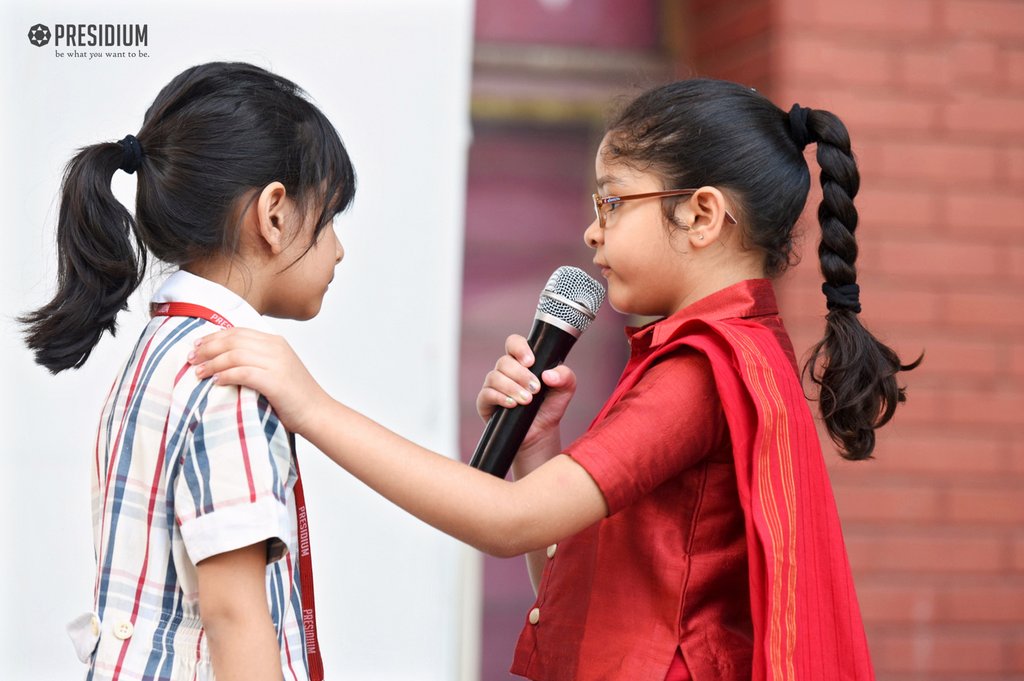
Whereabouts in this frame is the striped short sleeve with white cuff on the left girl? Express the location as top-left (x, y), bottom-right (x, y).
top-left (174, 381), bottom-right (294, 564)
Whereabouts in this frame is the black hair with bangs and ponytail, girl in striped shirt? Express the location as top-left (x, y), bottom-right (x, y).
top-left (20, 62), bottom-right (355, 373)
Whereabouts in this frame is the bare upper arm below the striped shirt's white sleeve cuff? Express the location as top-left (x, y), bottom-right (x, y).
top-left (196, 542), bottom-right (281, 681)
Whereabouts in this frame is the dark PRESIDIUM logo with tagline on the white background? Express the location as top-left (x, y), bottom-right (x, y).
top-left (29, 24), bottom-right (150, 60)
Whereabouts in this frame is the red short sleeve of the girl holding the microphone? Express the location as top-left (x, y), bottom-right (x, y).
top-left (566, 348), bottom-right (728, 514)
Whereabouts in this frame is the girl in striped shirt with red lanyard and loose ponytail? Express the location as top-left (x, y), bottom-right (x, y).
top-left (22, 62), bottom-right (355, 681)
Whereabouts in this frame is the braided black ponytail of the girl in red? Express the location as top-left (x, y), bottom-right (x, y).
top-left (802, 104), bottom-right (923, 460)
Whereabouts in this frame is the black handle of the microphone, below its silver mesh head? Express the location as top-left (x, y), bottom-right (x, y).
top-left (469, 320), bottom-right (577, 478)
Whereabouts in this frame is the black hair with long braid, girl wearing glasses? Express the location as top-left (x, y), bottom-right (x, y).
top-left (603, 79), bottom-right (921, 459)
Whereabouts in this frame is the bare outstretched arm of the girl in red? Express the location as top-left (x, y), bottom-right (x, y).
top-left (195, 329), bottom-right (607, 556)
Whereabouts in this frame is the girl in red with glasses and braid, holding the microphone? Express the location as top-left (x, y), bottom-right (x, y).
top-left (195, 79), bottom-right (916, 681)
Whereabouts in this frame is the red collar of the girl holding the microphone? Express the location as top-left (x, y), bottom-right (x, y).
top-left (626, 279), bottom-right (778, 351)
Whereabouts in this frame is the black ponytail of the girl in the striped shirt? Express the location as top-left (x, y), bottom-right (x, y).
top-left (19, 141), bottom-right (146, 374)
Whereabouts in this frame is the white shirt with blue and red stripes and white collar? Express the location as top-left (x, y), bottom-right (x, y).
top-left (69, 271), bottom-right (308, 681)
